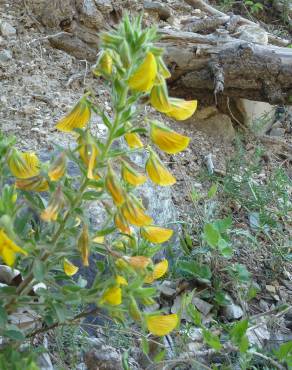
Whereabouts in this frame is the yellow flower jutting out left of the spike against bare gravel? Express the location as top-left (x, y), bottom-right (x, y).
top-left (56, 97), bottom-right (91, 132)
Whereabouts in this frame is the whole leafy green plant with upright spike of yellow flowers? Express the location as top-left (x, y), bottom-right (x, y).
top-left (0, 16), bottom-right (197, 370)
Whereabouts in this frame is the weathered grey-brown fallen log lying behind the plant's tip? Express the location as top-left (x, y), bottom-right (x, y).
top-left (25, 0), bottom-right (292, 104)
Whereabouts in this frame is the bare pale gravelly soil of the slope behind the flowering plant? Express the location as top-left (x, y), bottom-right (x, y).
top-left (0, 0), bottom-right (292, 370)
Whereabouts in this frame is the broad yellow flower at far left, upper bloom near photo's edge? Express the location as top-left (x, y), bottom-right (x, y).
top-left (8, 149), bottom-right (40, 179)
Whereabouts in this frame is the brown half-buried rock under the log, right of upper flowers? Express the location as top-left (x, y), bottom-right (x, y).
top-left (187, 110), bottom-right (235, 142)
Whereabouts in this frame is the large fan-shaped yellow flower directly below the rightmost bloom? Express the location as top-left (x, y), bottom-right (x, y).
top-left (150, 121), bottom-right (190, 154)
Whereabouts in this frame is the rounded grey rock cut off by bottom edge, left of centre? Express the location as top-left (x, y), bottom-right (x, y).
top-left (85, 345), bottom-right (123, 370)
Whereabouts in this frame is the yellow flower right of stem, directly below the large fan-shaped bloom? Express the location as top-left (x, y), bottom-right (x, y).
top-left (146, 152), bottom-right (176, 186)
